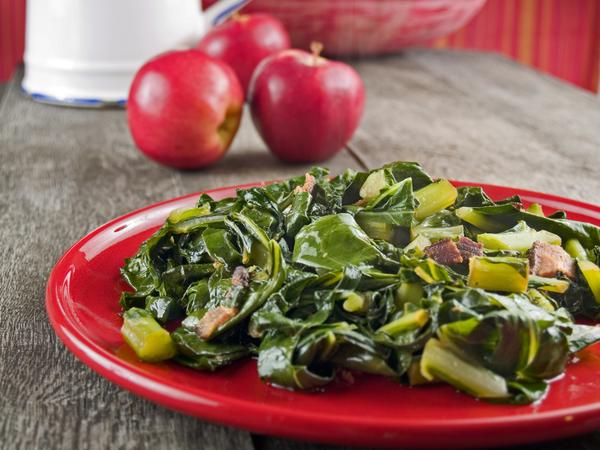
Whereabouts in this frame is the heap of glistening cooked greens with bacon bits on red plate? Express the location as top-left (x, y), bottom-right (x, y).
top-left (120, 162), bottom-right (600, 403)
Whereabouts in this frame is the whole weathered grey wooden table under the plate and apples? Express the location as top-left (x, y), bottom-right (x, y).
top-left (0, 51), bottom-right (600, 450)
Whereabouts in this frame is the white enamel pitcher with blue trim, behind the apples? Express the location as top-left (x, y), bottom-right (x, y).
top-left (22, 0), bottom-right (249, 107)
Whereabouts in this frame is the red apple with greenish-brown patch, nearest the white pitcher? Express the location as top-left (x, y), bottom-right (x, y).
top-left (127, 50), bottom-right (244, 169)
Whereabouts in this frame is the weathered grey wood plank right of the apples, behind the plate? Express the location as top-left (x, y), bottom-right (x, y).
top-left (352, 51), bottom-right (600, 202)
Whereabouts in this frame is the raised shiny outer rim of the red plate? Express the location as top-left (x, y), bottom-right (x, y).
top-left (45, 180), bottom-right (600, 446)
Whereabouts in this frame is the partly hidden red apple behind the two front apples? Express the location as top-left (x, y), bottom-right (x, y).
top-left (197, 14), bottom-right (290, 96)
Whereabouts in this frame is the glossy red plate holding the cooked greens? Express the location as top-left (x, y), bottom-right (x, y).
top-left (46, 183), bottom-right (600, 448)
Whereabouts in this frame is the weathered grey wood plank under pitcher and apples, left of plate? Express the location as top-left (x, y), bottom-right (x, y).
top-left (0, 72), bottom-right (355, 450)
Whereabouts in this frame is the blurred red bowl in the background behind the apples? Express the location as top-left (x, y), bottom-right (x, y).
top-left (203, 0), bottom-right (486, 56)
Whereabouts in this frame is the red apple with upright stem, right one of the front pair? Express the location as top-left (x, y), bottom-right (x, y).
top-left (248, 46), bottom-right (365, 162)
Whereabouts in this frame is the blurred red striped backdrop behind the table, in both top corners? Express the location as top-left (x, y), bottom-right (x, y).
top-left (0, 0), bottom-right (600, 92)
